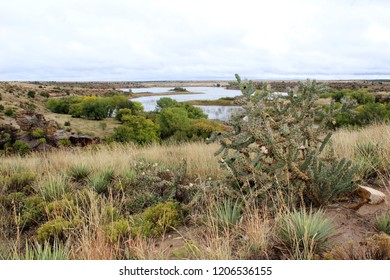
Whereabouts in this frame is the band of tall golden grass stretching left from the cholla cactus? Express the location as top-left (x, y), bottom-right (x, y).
top-left (0, 143), bottom-right (223, 178)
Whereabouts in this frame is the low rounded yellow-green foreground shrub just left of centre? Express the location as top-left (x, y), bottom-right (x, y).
top-left (131, 201), bottom-right (184, 237)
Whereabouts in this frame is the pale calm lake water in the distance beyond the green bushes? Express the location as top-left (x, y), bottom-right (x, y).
top-left (122, 87), bottom-right (241, 121)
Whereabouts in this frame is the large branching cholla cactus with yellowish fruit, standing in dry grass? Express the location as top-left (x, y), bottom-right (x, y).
top-left (212, 75), bottom-right (353, 204)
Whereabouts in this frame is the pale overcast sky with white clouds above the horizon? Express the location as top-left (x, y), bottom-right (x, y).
top-left (0, 0), bottom-right (390, 81)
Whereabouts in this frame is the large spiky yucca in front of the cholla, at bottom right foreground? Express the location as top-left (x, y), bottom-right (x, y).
top-left (278, 207), bottom-right (333, 259)
